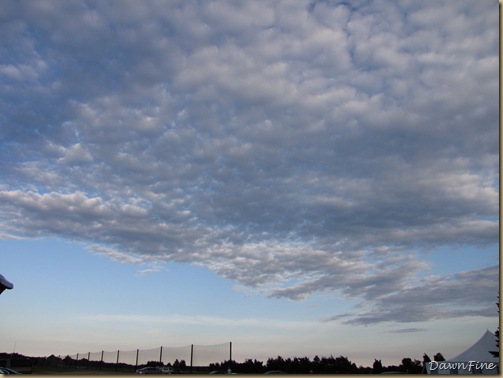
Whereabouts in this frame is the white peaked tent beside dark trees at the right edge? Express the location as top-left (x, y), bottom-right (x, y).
top-left (427, 331), bottom-right (499, 374)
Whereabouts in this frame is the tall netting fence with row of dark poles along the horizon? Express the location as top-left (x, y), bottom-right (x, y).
top-left (65, 342), bottom-right (232, 371)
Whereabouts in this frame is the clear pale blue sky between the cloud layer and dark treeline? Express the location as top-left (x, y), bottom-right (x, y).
top-left (0, 238), bottom-right (498, 366)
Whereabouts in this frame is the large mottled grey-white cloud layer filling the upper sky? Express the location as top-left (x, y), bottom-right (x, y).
top-left (0, 1), bottom-right (499, 323)
